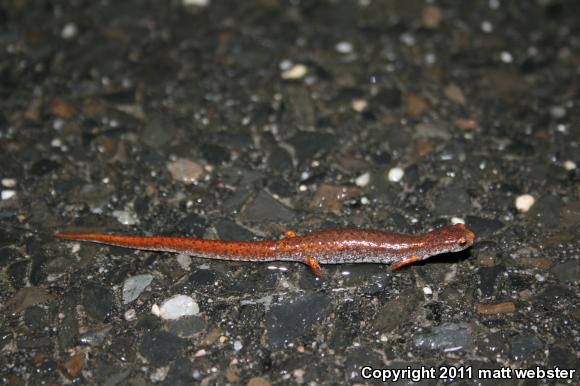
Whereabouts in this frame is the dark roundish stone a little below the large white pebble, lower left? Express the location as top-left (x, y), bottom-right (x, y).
top-left (139, 331), bottom-right (185, 367)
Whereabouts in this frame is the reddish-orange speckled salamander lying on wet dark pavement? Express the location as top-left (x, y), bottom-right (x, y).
top-left (54, 224), bottom-right (474, 276)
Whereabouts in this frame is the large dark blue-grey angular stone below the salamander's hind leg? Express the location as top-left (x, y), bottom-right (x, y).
top-left (266, 293), bottom-right (330, 347)
